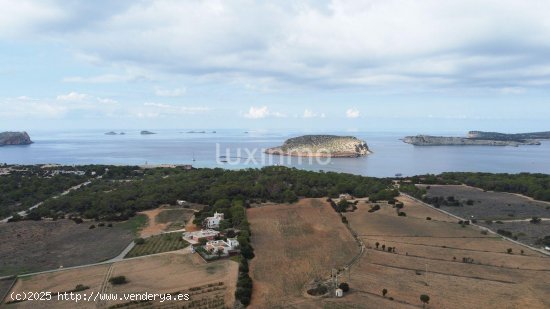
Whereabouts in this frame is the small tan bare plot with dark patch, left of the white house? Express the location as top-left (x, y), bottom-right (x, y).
top-left (140, 207), bottom-right (195, 237)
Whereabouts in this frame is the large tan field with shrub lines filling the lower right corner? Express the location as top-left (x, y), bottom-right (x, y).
top-left (342, 198), bottom-right (550, 308)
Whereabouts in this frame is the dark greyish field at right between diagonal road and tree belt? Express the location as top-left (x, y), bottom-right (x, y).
top-left (427, 185), bottom-right (550, 220)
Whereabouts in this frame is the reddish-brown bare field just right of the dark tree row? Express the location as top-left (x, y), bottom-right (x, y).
top-left (248, 199), bottom-right (359, 308)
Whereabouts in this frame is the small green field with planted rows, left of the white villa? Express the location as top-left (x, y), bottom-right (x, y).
top-left (124, 233), bottom-right (189, 258)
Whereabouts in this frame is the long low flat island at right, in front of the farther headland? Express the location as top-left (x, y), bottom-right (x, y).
top-left (402, 135), bottom-right (540, 147)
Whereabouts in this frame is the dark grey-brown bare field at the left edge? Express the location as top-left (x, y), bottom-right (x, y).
top-left (0, 220), bottom-right (133, 276)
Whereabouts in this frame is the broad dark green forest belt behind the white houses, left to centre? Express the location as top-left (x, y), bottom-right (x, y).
top-left (36, 167), bottom-right (391, 220)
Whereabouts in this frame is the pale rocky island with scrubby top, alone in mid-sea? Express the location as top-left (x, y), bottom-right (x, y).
top-left (265, 135), bottom-right (371, 158)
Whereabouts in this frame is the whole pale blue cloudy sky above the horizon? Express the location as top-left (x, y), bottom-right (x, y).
top-left (0, 0), bottom-right (550, 133)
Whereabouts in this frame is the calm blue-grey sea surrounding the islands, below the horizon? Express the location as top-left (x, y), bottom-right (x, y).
top-left (0, 129), bottom-right (550, 177)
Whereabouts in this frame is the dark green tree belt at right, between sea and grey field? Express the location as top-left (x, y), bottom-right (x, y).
top-left (410, 173), bottom-right (550, 201)
